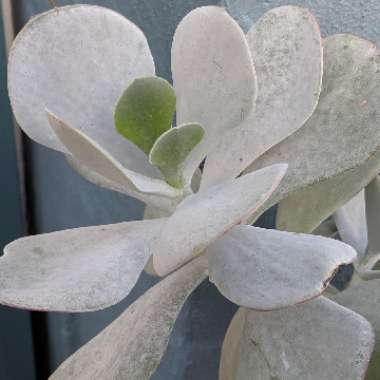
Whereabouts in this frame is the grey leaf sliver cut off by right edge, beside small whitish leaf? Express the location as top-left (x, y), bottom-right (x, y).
top-left (365, 174), bottom-right (380, 253)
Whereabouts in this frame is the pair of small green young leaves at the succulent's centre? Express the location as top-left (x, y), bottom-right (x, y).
top-left (115, 77), bottom-right (204, 188)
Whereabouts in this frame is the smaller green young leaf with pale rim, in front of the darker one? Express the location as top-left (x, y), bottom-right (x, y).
top-left (149, 123), bottom-right (205, 187)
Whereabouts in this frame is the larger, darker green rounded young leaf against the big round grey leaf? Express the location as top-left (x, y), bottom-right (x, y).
top-left (114, 77), bottom-right (176, 154)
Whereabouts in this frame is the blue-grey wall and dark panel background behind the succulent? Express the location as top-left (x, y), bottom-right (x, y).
top-left (0, 0), bottom-right (380, 380)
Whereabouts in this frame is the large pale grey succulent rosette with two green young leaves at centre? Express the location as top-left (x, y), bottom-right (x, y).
top-left (0, 5), bottom-right (380, 380)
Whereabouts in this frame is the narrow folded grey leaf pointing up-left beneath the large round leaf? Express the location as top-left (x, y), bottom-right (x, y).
top-left (48, 112), bottom-right (181, 201)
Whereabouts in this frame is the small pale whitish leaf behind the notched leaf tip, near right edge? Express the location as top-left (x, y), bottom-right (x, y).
top-left (333, 190), bottom-right (368, 257)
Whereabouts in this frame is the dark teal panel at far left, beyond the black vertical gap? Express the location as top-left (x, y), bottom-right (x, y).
top-left (0, 3), bottom-right (34, 380)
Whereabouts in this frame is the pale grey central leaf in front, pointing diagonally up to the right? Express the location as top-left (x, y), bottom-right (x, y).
top-left (153, 164), bottom-right (287, 275)
